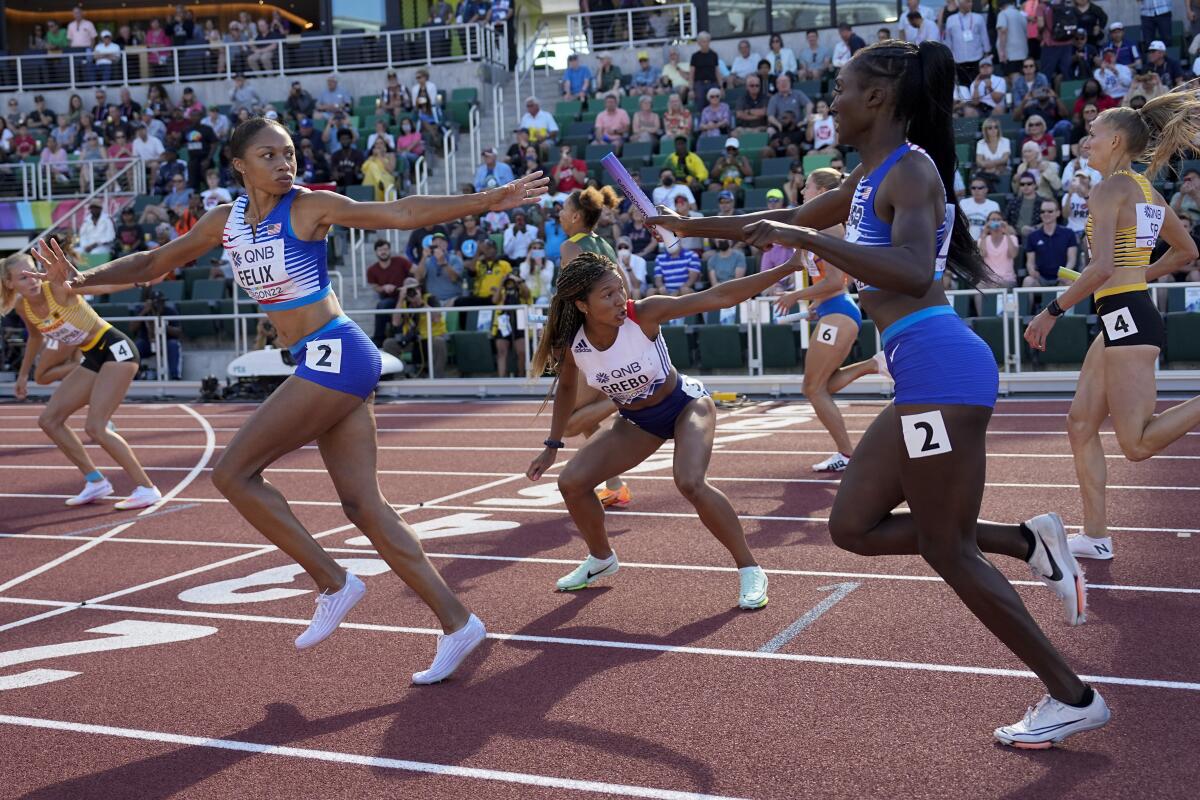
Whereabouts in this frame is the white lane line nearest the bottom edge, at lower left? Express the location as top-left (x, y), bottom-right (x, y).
top-left (0, 714), bottom-right (734, 800)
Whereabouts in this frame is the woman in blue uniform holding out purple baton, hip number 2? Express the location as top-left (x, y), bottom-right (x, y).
top-left (648, 41), bottom-right (1109, 748)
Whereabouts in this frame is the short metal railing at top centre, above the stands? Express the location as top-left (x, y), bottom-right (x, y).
top-left (566, 2), bottom-right (697, 53)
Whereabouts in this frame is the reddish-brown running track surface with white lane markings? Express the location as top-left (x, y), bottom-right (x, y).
top-left (0, 401), bottom-right (1200, 800)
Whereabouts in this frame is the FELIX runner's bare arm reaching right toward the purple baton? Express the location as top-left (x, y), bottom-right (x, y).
top-left (305, 172), bottom-right (550, 230)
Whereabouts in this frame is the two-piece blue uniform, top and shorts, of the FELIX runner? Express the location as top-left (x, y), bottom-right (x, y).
top-left (222, 188), bottom-right (383, 398)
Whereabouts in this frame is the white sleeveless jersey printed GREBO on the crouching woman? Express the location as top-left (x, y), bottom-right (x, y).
top-left (571, 300), bottom-right (671, 405)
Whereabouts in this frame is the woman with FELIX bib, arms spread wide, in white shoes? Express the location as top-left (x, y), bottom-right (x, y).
top-left (32, 118), bottom-right (547, 684)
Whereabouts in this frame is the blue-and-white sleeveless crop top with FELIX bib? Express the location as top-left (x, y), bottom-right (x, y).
top-left (222, 188), bottom-right (331, 311)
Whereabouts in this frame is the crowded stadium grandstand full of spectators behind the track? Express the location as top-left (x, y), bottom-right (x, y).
top-left (0, 0), bottom-right (1200, 393)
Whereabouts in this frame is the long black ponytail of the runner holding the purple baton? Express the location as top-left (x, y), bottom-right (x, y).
top-left (854, 40), bottom-right (996, 287)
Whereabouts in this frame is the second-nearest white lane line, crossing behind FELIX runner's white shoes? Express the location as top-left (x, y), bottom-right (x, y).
top-left (4, 601), bottom-right (1200, 692)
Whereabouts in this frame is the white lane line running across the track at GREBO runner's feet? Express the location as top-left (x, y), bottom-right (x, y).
top-left (0, 544), bottom-right (1200, 594)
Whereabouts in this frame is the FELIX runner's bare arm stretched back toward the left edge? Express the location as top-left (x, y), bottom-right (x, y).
top-left (30, 205), bottom-right (229, 294)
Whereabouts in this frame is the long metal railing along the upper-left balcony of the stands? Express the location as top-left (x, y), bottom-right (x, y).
top-left (0, 23), bottom-right (508, 91)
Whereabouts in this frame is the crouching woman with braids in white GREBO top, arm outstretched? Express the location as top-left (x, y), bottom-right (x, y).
top-left (526, 253), bottom-right (796, 609)
